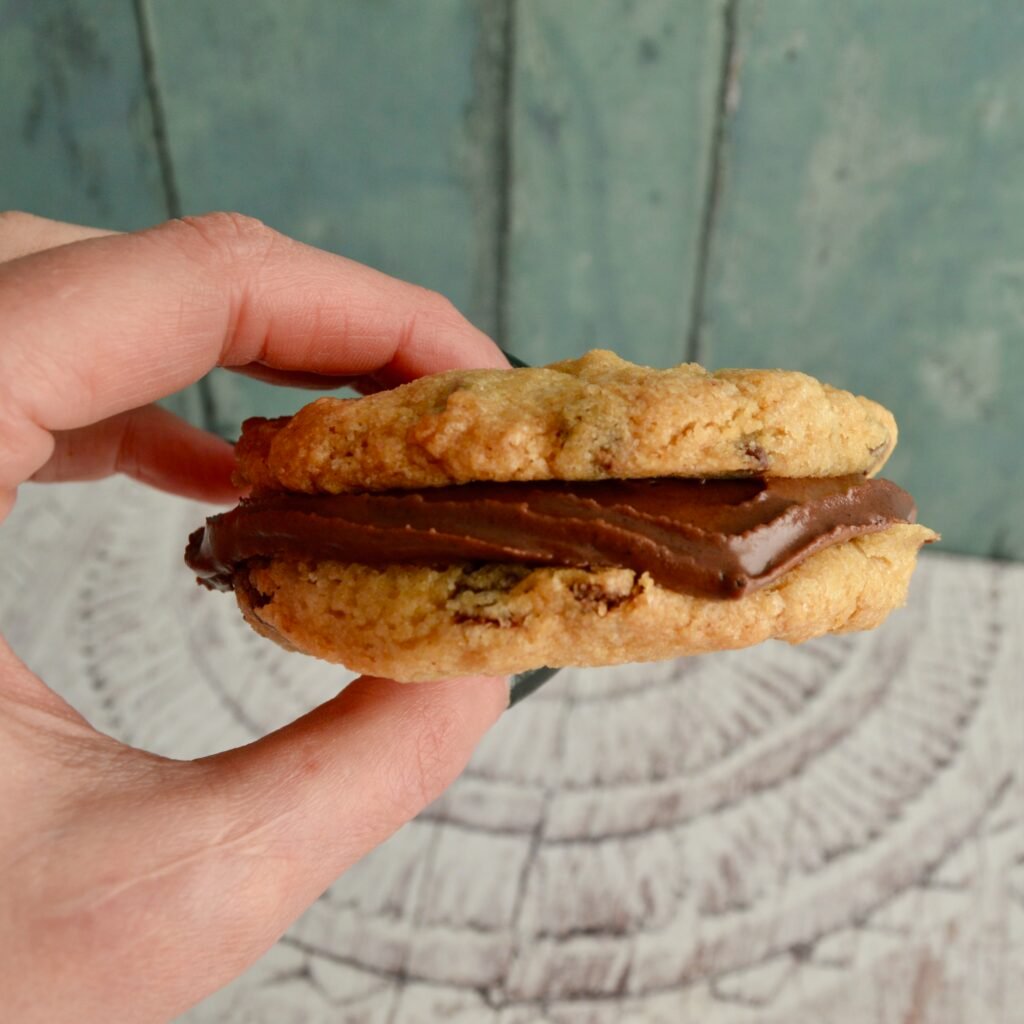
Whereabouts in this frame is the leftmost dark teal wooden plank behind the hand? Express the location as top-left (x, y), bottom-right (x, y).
top-left (0, 0), bottom-right (204, 423)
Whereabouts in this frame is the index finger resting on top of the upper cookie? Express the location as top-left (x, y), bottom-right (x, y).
top-left (0, 214), bottom-right (507, 487)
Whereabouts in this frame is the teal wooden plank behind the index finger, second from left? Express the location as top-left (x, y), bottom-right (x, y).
top-left (150, 0), bottom-right (503, 434)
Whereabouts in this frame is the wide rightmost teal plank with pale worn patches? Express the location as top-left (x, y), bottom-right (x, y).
top-left (703, 0), bottom-right (1024, 558)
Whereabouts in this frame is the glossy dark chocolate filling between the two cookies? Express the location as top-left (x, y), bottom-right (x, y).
top-left (185, 476), bottom-right (916, 597)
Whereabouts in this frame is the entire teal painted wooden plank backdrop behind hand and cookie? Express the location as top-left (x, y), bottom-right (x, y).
top-left (0, 0), bottom-right (1024, 558)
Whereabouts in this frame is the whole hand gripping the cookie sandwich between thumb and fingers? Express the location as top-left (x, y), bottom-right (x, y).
top-left (0, 214), bottom-right (508, 1024)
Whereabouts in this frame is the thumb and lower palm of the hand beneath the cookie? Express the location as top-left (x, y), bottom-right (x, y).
top-left (0, 659), bottom-right (508, 1021)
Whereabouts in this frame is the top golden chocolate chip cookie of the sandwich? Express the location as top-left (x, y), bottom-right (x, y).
top-left (238, 351), bottom-right (896, 494)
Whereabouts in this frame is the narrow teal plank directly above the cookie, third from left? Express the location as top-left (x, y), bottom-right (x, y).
top-left (505, 0), bottom-right (723, 366)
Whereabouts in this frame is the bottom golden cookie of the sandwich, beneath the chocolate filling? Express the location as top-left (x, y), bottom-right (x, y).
top-left (236, 525), bottom-right (935, 682)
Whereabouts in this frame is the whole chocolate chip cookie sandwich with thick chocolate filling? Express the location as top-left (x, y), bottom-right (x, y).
top-left (185, 351), bottom-right (936, 682)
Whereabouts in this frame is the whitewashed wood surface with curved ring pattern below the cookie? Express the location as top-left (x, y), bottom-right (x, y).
top-left (0, 480), bottom-right (1024, 1024)
